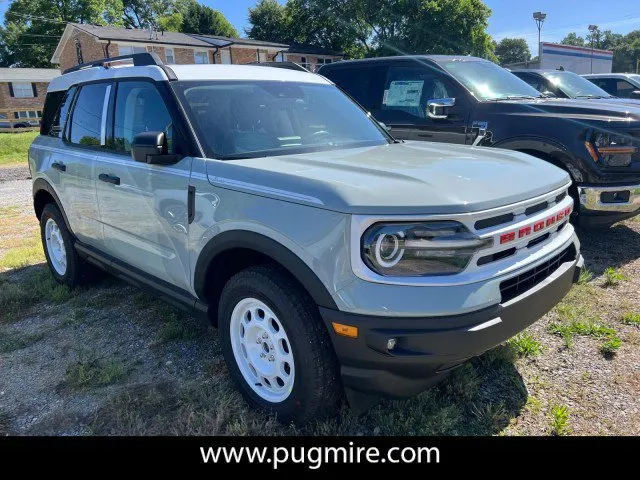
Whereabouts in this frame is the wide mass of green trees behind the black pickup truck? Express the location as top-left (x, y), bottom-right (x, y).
top-left (247, 0), bottom-right (495, 58)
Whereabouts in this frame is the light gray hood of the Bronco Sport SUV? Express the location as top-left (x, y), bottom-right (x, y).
top-left (207, 142), bottom-right (570, 214)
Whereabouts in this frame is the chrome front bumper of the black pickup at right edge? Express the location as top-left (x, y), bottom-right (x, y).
top-left (578, 184), bottom-right (640, 227)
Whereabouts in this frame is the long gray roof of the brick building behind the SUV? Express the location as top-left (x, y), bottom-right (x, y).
top-left (51, 23), bottom-right (342, 63)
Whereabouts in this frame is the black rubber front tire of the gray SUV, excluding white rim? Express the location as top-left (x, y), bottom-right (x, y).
top-left (218, 264), bottom-right (342, 424)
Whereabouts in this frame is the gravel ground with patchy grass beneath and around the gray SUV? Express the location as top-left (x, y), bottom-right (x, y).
top-left (0, 169), bottom-right (640, 435)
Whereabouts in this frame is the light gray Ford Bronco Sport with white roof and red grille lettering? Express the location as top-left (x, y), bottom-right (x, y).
top-left (29, 54), bottom-right (582, 423)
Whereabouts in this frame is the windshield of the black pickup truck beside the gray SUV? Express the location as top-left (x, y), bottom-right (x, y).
top-left (440, 60), bottom-right (541, 100)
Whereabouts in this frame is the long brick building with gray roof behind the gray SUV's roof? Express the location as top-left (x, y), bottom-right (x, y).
top-left (51, 23), bottom-right (343, 71)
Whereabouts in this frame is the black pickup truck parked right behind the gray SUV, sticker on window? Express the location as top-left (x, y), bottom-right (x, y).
top-left (319, 55), bottom-right (640, 227)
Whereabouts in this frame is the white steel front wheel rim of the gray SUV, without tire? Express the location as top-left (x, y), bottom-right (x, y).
top-left (229, 298), bottom-right (295, 403)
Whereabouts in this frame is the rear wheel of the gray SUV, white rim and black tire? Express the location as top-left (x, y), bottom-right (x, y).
top-left (40, 203), bottom-right (82, 287)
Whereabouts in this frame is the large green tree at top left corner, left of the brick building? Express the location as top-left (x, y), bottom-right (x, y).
top-left (0, 0), bottom-right (123, 67)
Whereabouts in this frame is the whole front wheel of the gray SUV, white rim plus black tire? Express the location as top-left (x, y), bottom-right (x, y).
top-left (218, 265), bottom-right (340, 424)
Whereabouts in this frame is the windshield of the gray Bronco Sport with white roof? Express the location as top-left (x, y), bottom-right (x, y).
top-left (175, 81), bottom-right (390, 159)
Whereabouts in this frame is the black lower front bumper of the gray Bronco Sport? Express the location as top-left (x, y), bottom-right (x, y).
top-left (320, 253), bottom-right (584, 405)
